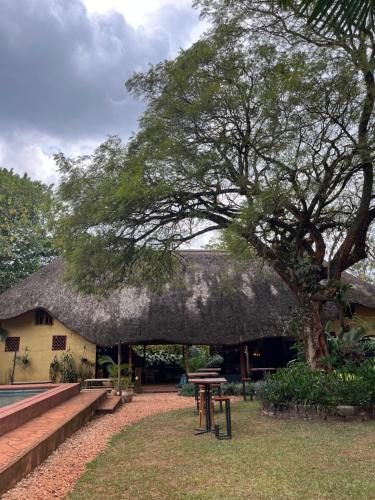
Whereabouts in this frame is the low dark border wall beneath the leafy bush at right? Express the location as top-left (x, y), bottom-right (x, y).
top-left (261, 401), bottom-right (375, 421)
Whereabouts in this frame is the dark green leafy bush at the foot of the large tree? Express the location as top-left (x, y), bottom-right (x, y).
top-left (257, 360), bottom-right (375, 406)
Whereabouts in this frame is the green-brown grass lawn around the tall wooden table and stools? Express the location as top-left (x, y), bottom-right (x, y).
top-left (69, 402), bottom-right (375, 500)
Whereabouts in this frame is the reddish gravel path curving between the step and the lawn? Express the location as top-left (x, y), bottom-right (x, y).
top-left (2, 393), bottom-right (194, 500)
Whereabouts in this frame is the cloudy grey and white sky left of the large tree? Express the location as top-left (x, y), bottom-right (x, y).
top-left (0, 0), bottom-right (205, 183)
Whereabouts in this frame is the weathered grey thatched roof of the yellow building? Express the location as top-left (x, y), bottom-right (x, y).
top-left (0, 250), bottom-right (375, 345)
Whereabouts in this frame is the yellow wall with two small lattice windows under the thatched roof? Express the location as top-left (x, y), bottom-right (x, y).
top-left (0, 311), bottom-right (96, 384)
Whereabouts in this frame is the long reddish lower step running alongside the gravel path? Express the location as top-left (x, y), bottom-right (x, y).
top-left (0, 389), bottom-right (106, 495)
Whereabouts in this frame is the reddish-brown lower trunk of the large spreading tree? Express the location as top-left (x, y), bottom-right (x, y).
top-left (303, 299), bottom-right (328, 368)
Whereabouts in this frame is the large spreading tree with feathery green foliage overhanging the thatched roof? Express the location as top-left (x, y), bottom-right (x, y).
top-left (57, 6), bottom-right (375, 372)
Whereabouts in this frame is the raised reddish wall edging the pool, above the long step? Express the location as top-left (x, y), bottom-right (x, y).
top-left (0, 384), bottom-right (80, 436)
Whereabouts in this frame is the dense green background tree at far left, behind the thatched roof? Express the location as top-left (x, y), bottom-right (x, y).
top-left (0, 169), bottom-right (55, 292)
